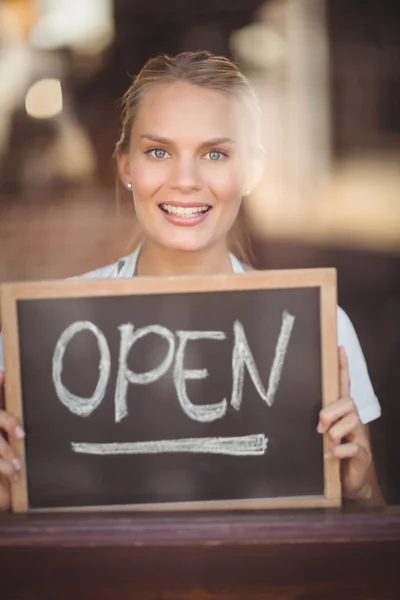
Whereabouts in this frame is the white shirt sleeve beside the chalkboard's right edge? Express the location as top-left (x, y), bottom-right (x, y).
top-left (337, 306), bottom-right (381, 423)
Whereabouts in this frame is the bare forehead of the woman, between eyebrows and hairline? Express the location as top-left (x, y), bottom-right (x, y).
top-left (133, 82), bottom-right (240, 140)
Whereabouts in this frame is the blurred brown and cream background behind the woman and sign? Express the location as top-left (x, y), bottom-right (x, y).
top-left (0, 0), bottom-right (400, 504)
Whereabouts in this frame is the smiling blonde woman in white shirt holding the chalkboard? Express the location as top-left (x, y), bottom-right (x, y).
top-left (0, 51), bottom-right (380, 510)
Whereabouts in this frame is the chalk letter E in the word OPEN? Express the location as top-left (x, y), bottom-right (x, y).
top-left (174, 331), bottom-right (228, 423)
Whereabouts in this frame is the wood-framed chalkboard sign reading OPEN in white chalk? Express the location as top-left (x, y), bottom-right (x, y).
top-left (2, 269), bottom-right (340, 511)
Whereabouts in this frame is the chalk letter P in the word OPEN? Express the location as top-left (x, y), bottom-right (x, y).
top-left (114, 323), bottom-right (175, 423)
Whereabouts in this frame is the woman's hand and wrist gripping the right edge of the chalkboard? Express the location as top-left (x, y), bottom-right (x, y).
top-left (317, 348), bottom-right (372, 500)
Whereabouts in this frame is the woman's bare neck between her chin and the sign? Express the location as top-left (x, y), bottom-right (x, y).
top-left (136, 242), bottom-right (232, 276)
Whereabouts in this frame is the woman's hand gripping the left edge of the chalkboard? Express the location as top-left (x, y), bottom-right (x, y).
top-left (0, 371), bottom-right (25, 511)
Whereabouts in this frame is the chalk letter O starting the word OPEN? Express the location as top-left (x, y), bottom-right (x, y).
top-left (52, 321), bottom-right (111, 417)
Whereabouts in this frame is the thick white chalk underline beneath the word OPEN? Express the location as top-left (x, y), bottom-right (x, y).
top-left (71, 433), bottom-right (268, 456)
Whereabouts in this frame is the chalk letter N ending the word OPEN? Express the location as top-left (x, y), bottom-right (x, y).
top-left (231, 311), bottom-right (295, 410)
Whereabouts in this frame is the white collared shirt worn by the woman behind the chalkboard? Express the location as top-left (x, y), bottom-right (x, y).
top-left (0, 248), bottom-right (381, 423)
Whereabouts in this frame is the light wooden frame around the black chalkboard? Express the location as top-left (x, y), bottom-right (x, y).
top-left (1, 269), bottom-right (341, 512)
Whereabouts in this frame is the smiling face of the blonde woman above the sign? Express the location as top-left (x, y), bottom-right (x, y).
top-left (119, 82), bottom-right (250, 251)
